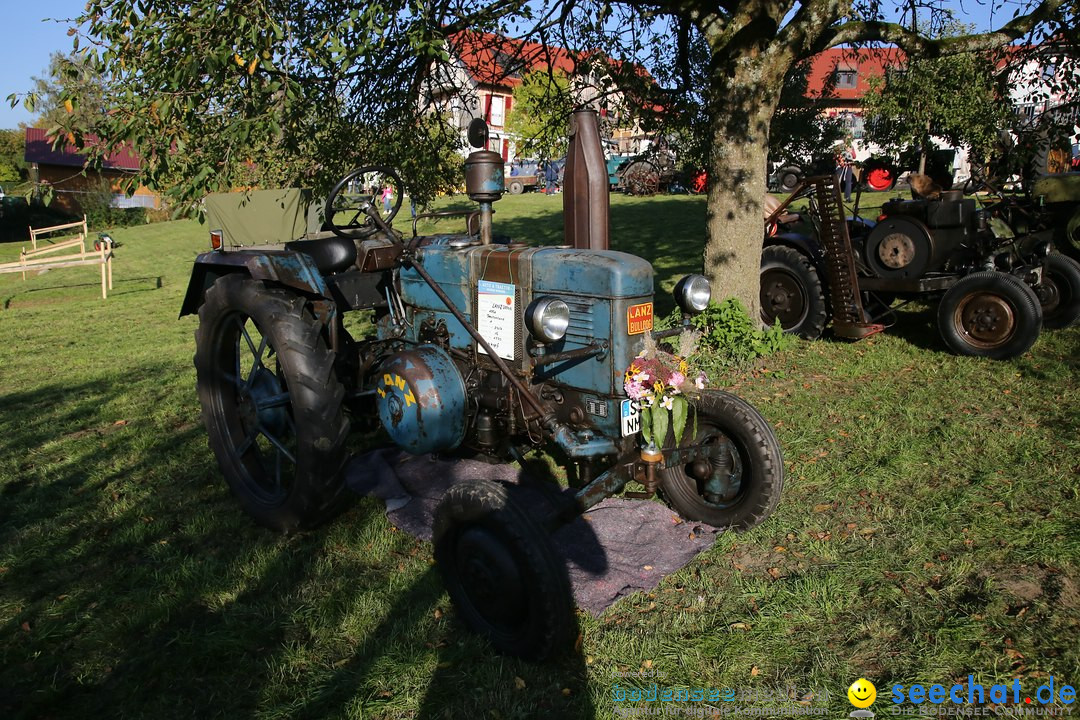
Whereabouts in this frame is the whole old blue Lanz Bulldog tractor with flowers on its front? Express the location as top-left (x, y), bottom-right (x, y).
top-left (180, 111), bottom-right (783, 658)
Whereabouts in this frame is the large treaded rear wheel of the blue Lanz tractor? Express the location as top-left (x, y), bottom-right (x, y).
top-left (194, 274), bottom-right (349, 532)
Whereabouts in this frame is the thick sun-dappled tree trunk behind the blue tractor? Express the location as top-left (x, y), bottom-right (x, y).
top-left (703, 58), bottom-right (786, 318)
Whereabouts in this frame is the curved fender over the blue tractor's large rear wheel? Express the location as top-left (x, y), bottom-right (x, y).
top-left (180, 250), bottom-right (329, 317)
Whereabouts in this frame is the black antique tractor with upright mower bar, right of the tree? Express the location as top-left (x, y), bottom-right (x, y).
top-left (760, 177), bottom-right (1080, 358)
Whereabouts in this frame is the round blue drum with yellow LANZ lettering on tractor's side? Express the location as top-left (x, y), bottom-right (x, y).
top-left (375, 345), bottom-right (467, 454)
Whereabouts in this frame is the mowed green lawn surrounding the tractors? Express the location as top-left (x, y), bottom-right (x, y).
top-left (0, 194), bottom-right (1080, 719)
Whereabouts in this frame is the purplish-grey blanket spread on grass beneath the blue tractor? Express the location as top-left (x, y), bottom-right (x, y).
top-left (346, 450), bottom-right (716, 615)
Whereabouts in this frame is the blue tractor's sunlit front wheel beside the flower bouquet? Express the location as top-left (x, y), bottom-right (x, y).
top-left (660, 391), bottom-right (784, 530)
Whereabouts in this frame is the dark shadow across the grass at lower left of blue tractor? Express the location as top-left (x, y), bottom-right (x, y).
top-left (0, 366), bottom-right (592, 718)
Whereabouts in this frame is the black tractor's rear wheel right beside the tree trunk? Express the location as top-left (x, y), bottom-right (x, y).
top-left (759, 245), bottom-right (828, 340)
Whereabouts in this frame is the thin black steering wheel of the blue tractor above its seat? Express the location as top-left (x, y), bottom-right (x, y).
top-left (325, 165), bottom-right (405, 240)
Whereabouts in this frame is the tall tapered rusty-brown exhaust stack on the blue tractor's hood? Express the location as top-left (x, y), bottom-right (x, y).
top-left (563, 109), bottom-right (610, 250)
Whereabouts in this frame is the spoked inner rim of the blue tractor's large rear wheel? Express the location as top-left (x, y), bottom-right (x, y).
top-left (222, 314), bottom-right (296, 497)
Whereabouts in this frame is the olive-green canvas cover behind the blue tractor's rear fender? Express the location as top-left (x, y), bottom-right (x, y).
top-left (204, 188), bottom-right (322, 246)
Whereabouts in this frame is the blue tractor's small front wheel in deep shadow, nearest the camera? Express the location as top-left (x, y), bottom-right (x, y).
top-left (433, 479), bottom-right (576, 661)
